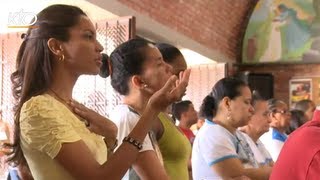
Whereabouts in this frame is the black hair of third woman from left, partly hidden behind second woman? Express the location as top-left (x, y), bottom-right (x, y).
top-left (155, 43), bottom-right (182, 64)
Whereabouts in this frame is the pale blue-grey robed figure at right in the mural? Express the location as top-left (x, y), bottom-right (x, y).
top-left (274, 4), bottom-right (310, 53)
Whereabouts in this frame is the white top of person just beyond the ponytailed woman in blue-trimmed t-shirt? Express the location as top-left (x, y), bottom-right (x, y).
top-left (242, 132), bottom-right (272, 165)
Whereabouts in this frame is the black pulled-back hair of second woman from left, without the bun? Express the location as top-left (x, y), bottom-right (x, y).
top-left (110, 39), bottom-right (150, 95)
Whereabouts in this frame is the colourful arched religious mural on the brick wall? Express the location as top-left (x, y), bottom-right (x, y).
top-left (242, 0), bottom-right (320, 63)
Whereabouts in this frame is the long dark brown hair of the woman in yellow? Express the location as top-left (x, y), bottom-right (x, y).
top-left (5, 4), bottom-right (86, 165)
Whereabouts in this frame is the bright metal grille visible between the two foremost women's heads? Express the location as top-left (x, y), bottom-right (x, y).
top-left (73, 17), bottom-right (135, 116)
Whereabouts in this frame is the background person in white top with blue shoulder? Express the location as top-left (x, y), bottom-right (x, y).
top-left (260, 99), bottom-right (291, 161)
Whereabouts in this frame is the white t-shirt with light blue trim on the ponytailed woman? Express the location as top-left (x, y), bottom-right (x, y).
top-left (191, 120), bottom-right (259, 180)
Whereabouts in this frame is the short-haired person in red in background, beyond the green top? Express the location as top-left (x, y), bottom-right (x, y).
top-left (172, 100), bottom-right (198, 144)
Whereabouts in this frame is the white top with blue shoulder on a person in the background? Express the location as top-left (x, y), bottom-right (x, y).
top-left (260, 127), bottom-right (287, 162)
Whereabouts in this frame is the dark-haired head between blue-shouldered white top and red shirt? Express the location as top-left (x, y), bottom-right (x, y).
top-left (286, 109), bottom-right (307, 135)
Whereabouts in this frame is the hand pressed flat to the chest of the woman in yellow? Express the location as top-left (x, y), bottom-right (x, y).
top-left (70, 100), bottom-right (118, 148)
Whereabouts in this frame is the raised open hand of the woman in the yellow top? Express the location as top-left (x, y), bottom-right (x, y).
top-left (148, 69), bottom-right (191, 111)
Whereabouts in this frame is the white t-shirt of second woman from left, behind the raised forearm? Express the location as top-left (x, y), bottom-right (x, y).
top-left (110, 104), bottom-right (154, 180)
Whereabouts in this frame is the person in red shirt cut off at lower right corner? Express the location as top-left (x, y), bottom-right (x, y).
top-left (270, 109), bottom-right (320, 180)
